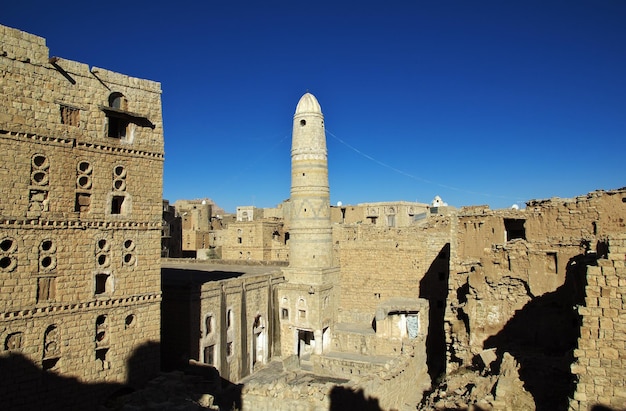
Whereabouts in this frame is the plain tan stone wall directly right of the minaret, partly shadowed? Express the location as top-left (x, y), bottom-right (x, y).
top-left (334, 217), bottom-right (453, 322)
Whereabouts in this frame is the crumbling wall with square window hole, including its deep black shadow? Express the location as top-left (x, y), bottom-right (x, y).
top-left (445, 189), bottom-right (626, 409)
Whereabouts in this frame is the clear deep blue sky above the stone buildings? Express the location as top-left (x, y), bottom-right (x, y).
top-left (0, 0), bottom-right (626, 212)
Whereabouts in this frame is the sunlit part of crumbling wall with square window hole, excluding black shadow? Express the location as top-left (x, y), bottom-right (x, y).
top-left (447, 189), bottom-right (626, 366)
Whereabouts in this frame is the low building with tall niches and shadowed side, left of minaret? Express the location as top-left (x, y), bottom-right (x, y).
top-left (162, 265), bottom-right (284, 381)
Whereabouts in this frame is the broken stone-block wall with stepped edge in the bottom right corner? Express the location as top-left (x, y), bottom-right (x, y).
top-left (570, 234), bottom-right (626, 411)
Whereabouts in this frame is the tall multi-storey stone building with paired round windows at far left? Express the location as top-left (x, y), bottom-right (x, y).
top-left (0, 26), bottom-right (163, 406)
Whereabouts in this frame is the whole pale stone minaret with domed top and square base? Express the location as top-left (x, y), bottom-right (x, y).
top-left (278, 93), bottom-right (339, 360)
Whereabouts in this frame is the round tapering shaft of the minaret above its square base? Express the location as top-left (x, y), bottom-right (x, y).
top-left (289, 93), bottom-right (333, 274)
